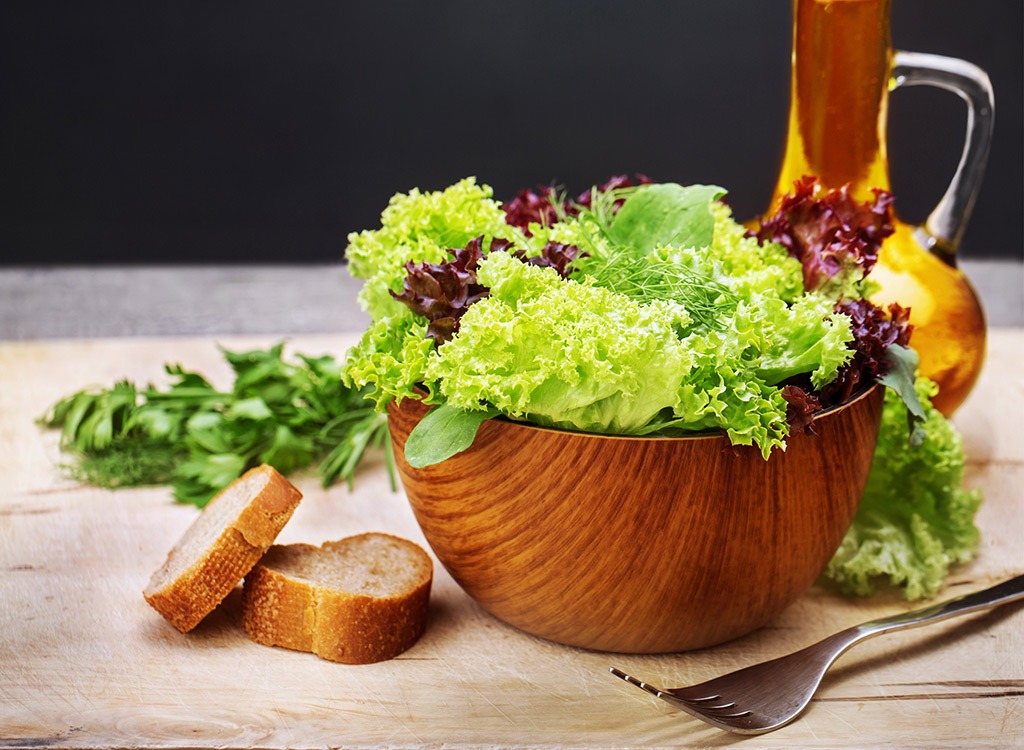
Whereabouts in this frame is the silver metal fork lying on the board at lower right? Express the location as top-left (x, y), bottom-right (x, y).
top-left (611, 575), bottom-right (1024, 735)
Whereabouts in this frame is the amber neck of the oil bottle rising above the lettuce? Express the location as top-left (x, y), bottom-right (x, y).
top-left (772, 0), bottom-right (892, 205)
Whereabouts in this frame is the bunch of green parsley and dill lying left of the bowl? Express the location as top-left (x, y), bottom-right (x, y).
top-left (40, 344), bottom-right (391, 507)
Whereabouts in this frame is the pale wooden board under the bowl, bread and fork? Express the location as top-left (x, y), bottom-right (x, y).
top-left (0, 329), bottom-right (1024, 748)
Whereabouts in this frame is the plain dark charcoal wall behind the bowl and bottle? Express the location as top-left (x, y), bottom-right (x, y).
top-left (0, 0), bottom-right (1024, 264)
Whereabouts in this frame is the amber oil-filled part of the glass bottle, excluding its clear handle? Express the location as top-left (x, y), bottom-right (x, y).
top-left (772, 0), bottom-right (985, 415)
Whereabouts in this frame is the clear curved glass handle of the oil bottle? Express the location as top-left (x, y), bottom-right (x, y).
top-left (889, 50), bottom-right (995, 266)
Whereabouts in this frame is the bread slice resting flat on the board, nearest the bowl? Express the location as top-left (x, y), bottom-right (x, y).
top-left (242, 533), bottom-right (433, 664)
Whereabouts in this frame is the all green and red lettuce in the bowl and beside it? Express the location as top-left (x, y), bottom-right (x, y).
top-left (343, 176), bottom-right (980, 597)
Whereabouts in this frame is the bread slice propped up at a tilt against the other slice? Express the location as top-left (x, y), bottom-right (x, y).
top-left (143, 464), bottom-right (302, 632)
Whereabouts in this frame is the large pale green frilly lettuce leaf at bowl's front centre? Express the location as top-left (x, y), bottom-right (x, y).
top-left (426, 252), bottom-right (694, 434)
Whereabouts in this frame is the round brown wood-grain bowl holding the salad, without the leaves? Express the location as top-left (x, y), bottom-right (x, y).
top-left (388, 385), bottom-right (883, 654)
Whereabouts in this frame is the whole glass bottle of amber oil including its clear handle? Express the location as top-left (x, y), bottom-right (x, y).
top-left (771, 0), bottom-right (993, 416)
